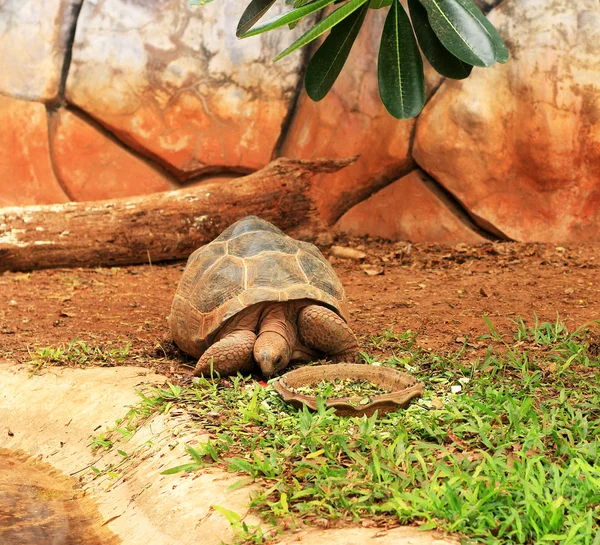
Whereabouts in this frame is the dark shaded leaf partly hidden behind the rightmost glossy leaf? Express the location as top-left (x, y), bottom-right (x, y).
top-left (408, 0), bottom-right (473, 79)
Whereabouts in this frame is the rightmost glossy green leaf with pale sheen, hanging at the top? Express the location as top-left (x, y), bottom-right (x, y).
top-left (420, 0), bottom-right (496, 66)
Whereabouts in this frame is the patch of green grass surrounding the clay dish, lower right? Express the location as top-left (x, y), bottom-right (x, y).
top-left (94, 320), bottom-right (600, 545)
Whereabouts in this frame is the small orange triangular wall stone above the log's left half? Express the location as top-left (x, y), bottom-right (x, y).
top-left (50, 109), bottom-right (175, 201)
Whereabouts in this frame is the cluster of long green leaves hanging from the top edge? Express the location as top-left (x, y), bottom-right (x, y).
top-left (190, 0), bottom-right (509, 119)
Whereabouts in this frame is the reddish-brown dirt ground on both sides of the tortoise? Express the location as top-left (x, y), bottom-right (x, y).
top-left (0, 240), bottom-right (600, 376)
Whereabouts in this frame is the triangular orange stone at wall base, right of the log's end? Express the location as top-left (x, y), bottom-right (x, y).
top-left (335, 170), bottom-right (486, 244)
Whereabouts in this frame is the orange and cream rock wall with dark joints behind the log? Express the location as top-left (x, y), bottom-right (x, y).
top-left (0, 0), bottom-right (600, 243)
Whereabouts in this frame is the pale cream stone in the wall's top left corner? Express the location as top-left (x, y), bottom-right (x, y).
top-left (0, 0), bottom-right (83, 102)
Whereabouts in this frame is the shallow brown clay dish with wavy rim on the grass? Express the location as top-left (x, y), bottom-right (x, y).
top-left (273, 363), bottom-right (423, 416)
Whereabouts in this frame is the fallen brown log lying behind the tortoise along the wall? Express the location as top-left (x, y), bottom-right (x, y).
top-left (0, 158), bottom-right (354, 271)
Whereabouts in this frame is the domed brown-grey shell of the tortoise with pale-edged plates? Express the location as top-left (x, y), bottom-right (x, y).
top-left (168, 216), bottom-right (348, 358)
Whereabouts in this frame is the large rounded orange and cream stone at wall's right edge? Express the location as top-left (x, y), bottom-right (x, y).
top-left (414, 0), bottom-right (600, 243)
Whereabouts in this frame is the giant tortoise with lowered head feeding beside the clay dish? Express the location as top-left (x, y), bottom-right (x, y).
top-left (168, 216), bottom-right (358, 377)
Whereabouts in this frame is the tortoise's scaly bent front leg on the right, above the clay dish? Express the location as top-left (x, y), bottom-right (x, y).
top-left (298, 305), bottom-right (358, 363)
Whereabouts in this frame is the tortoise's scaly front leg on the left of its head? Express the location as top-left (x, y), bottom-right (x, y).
top-left (194, 331), bottom-right (256, 377)
